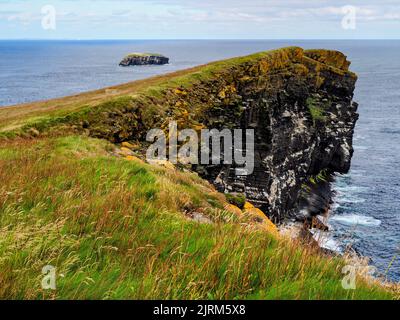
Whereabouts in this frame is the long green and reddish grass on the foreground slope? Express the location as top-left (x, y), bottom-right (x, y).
top-left (0, 136), bottom-right (393, 299)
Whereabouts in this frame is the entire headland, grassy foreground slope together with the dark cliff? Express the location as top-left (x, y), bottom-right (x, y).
top-left (0, 47), bottom-right (392, 299)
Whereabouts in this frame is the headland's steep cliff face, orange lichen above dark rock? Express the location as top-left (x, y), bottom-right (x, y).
top-left (42, 47), bottom-right (358, 220)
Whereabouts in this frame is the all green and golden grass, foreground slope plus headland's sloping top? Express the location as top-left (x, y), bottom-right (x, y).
top-left (0, 48), bottom-right (395, 299)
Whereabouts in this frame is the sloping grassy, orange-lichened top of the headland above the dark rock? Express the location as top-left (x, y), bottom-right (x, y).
top-left (0, 47), bottom-right (356, 140)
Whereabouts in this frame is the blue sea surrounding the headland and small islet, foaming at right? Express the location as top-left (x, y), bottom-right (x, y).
top-left (0, 41), bottom-right (400, 281)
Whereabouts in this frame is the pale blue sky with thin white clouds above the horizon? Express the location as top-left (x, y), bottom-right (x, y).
top-left (0, 0), bottom-right (400, 39)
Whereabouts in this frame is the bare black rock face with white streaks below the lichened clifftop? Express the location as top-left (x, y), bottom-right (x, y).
top-left (192, 48), bottom-right (358, 221)
